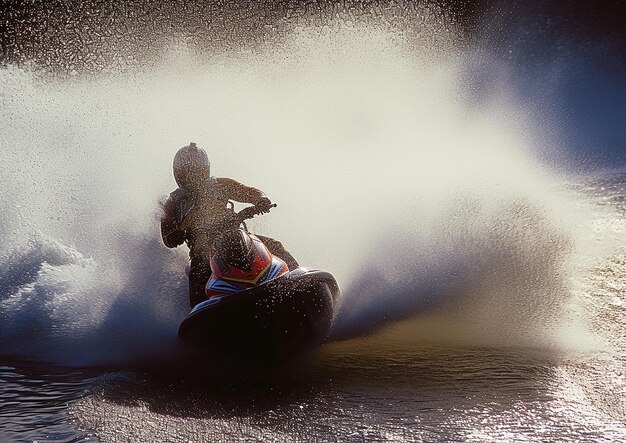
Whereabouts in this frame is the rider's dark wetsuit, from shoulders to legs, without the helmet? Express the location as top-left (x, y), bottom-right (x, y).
top-left (161, 177), bottom-right (298, 307)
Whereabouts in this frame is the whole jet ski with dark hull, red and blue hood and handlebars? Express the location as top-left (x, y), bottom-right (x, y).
top-left (178, 205), bottom-right (339, 366)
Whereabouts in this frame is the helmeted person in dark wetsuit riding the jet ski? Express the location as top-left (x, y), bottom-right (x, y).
top-left (161, 142), bottom-right (298, 307)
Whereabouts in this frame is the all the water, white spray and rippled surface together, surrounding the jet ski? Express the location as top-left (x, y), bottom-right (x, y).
top-left (0, 3), bottom-right (626, 442)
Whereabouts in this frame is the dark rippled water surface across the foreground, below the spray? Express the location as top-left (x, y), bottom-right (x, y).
top-left (2, 345), bottom-right (626, 442)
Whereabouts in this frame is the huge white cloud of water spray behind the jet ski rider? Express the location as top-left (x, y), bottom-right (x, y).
top-left (0, 22), bottom-right (608, 364)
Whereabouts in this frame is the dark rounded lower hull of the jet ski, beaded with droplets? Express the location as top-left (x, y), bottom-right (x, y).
top-left (178, 268), bottom-right (339, 364)
